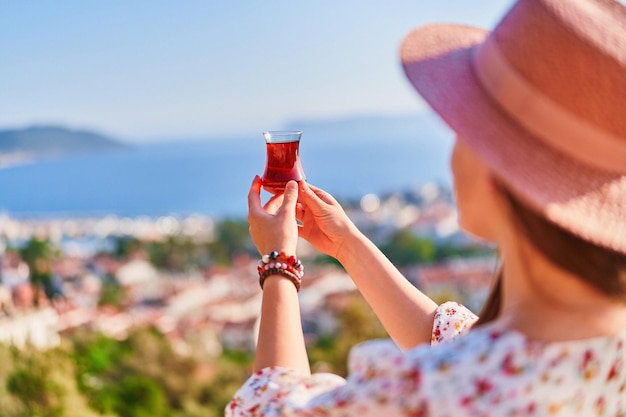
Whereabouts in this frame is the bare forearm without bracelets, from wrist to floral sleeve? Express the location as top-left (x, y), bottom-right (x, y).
top-left (338, 231), bottom-right (437, 349)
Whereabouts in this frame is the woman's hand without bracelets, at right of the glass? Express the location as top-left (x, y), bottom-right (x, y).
top-left (296, 181), bottom-right (358, 259)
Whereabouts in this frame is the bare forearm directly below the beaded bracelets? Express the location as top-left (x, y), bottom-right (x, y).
top-left (254, 276), bottom-right (311, 374)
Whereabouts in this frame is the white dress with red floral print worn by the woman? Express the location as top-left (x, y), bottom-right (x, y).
top-left (226, 303), bottom-right (626, 417)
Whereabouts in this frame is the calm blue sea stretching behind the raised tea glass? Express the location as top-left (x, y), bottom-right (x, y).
top-left (0, 133), bottom-right (451, 218)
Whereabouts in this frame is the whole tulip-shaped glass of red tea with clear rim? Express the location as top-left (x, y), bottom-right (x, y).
top-left (262, 130), bottom-right (306, 194)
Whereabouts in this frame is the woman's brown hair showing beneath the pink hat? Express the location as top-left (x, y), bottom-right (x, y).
top-left (474, 184), bottom-right (626, 326)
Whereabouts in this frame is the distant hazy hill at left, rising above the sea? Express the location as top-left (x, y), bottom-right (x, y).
top-left (0, 126), bottom-right (128, 166)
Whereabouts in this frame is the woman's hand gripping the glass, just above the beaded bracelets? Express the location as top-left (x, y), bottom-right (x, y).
top-left (248, 175), bottom-right (298, 256)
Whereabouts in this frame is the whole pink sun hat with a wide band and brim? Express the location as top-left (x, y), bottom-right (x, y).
top-left (401, 0), bottom-right (626, 254)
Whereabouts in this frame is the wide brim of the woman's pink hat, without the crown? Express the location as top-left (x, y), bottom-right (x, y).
top-left (401, 24), bottom-right (626, 253)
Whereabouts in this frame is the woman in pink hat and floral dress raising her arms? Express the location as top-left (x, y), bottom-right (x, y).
top-left (226, 0), bottom-right (626, 417)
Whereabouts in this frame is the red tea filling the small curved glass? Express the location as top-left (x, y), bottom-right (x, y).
top-left (263, 141), bottom-right (305, 194)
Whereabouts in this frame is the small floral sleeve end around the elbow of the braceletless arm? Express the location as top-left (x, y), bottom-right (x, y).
top-left (431, 301), bottom-right (478, 345)
